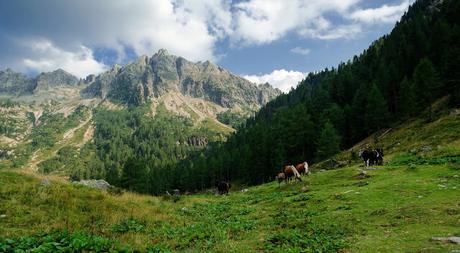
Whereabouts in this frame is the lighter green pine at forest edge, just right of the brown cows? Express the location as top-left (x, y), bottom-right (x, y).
top-left (316, 122), bottom-right (340, 161)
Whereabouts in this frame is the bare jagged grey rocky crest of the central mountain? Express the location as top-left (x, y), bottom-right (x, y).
top-left (82, 49), bottom-right (281, 109)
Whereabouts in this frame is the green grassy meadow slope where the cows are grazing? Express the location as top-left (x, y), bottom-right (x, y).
top-left (0, 110), bottom-right (460, 252)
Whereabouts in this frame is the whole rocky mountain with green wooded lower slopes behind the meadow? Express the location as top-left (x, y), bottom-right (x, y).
top-left (0, 49), bottom-right (281, 194)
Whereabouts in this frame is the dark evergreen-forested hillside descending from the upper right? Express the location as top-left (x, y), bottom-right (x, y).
top-left (165, 0), bottom-right (460, 188)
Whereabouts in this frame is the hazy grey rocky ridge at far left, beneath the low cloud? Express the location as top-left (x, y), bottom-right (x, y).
top-left (0, 69), bottom-right (79, 95)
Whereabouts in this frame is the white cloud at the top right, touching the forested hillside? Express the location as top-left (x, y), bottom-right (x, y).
top-left (349, 0), bottom-right (410, 24)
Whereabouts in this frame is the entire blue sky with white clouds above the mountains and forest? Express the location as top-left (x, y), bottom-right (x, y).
top-left (0, 0), bottom-right (414, 91)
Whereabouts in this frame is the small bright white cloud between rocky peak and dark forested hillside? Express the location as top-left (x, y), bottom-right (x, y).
top-left (243, 69), bottom-right (308, 92)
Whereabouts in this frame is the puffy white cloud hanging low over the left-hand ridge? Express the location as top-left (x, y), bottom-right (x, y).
top-left (23, 40), bottom-right (107, 77)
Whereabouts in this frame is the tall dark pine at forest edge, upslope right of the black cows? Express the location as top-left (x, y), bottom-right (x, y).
top-left (412, 58), bottom-right (440, 121)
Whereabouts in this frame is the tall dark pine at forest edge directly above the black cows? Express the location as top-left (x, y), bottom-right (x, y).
top-left (365, 84), bottom-right (389, 134)
